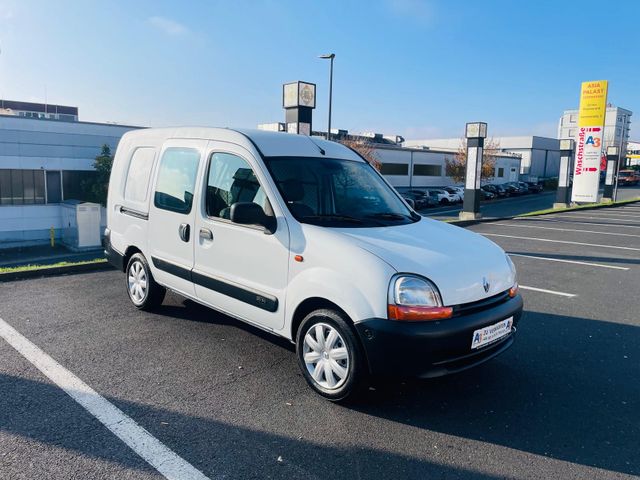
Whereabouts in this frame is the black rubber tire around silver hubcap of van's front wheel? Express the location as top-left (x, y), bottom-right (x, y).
top-left (296, 309), bottom-right (369, 402)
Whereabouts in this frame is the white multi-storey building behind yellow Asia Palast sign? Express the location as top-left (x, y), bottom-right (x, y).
top-left (558, 104), bottom-right (633, 152)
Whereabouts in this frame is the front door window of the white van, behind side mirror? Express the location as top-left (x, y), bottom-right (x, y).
top-left (205, 153), bottom-right (268, 219)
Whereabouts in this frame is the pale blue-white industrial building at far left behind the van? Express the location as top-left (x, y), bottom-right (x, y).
top-left (0, 107), bottom-right (138, 248)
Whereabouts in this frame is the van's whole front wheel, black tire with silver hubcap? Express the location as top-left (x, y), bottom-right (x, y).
top-left (296, 309), bottom-right (367, 402)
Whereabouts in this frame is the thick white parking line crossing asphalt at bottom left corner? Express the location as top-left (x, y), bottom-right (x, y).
top-left (0, 318), bottom-right (208, 480)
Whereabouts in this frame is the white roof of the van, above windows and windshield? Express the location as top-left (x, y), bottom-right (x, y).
top-left (117, 127), bottom-right (363, 161)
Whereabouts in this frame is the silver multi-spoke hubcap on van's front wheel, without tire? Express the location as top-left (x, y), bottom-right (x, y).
top-left (302, 323), bottom-right (349, 390)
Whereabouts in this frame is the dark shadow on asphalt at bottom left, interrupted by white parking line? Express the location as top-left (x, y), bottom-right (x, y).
top-left (0, 374), bottom-right (499, 480)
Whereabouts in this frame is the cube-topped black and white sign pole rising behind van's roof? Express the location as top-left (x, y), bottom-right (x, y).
top-left (282, 81), bottom-right (316, 136)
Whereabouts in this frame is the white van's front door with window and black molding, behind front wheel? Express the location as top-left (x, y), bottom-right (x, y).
top-left (193, 142), bottom-right (289, 330)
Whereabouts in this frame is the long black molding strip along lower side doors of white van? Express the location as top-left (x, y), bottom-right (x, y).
top-left (151, 257), bottom-right (278, 312)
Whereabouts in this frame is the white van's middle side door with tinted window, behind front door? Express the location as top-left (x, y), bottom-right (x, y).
top-left (147, 140), bottom-right (207, 296)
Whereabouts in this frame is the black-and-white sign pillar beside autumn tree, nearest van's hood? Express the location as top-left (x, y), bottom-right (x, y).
top-left (460, 122), bottom-right (487, 220)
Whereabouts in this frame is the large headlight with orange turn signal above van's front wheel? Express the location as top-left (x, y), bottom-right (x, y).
top-left (388, 275), bottom-right (453, 321)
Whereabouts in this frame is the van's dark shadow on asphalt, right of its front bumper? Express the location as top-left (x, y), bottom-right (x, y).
top-left (350, 312), bottom-right (640, 475)
